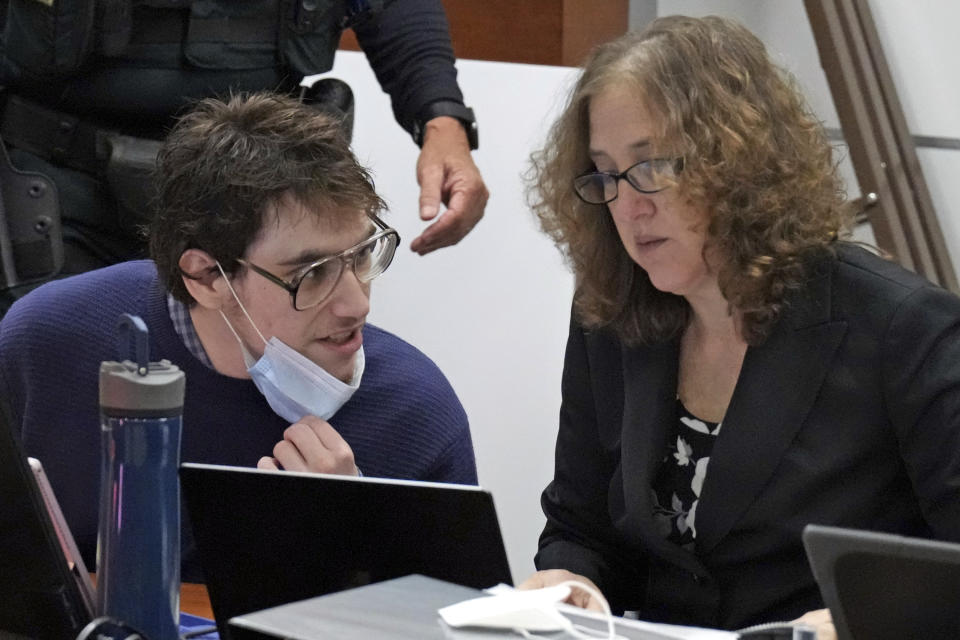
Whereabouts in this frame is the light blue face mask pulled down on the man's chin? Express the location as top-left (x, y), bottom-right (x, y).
top-left (217, 263), bottom-right (366, 423)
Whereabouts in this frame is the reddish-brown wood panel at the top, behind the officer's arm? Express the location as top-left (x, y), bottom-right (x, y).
top-left (340, 0), bottom-right (628, 66)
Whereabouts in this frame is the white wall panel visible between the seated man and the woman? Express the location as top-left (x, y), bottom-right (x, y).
top-left (316, 51), bottom-right (575, 580)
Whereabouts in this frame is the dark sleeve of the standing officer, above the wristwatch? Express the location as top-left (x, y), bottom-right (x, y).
top-left (353, 0), bottom-right (463, 132)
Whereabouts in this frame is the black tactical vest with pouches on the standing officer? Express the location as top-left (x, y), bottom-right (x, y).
top-left (2, 0), bottom-right (383, 82)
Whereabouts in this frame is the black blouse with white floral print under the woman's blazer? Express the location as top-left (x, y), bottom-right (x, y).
top-left (651, 398), bottom-right (722, 550)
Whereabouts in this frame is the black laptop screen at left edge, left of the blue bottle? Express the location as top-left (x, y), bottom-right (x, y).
top-left (0, 401), bottom-right (91, 640)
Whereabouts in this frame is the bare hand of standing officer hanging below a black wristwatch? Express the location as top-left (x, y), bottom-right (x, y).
top-left (410, 116), bottom-right (490, 255)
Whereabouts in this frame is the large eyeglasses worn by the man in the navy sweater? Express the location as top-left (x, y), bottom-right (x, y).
top-left (237, 215), bottom-right (400, 311)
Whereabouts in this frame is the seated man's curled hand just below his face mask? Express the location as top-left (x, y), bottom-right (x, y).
top-left (257, 416), bottom-right (359, 476)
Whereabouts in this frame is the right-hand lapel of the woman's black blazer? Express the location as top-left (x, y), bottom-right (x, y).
top-left (696, 262), bottom-right (847, 554)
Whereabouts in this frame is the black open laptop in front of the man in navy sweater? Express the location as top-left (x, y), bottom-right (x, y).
top-left (180, 463), bottom-right (512, 638)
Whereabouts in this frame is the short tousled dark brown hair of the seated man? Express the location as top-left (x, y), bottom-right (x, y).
top-left (150, 92), bottom-right (385, 304)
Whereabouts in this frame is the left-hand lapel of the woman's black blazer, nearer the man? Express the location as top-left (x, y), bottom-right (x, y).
top-left (620, 340), bottom-right (706, 575)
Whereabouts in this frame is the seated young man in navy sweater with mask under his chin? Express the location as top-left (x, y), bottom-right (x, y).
top-left (0, 94), bottom-right (477, 581)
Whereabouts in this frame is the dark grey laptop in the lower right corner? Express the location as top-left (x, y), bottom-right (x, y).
top-left (803, 525), bottom-right (960, 640)
